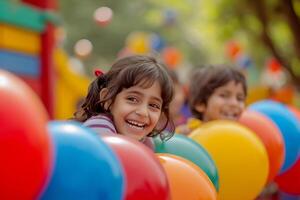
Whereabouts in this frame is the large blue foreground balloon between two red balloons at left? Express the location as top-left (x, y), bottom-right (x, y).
top-left (41, 121), bottom-right (125, 200)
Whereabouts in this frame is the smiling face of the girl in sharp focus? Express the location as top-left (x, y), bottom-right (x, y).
top-left (110, 81), bottom-right (163, 140)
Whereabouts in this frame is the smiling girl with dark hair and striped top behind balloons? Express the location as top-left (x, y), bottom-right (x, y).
top-left (75, 55), bottom-right (174, 142)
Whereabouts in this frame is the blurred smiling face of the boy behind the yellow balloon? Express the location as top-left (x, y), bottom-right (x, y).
top-left (196, 81), bottom-right (246, 122)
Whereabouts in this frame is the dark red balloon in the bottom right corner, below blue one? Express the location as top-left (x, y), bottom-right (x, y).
top-left (275, 158), bottom-right (300, 195)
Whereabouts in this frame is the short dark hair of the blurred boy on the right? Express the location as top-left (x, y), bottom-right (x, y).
top-left (189, 65), bottom-right (247, 120)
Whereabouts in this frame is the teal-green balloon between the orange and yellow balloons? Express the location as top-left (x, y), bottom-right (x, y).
top-left (154, 134), bottom-right (219, 190)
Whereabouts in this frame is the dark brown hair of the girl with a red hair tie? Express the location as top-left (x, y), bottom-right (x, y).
top-left (74, 55), bottom-right (174, 139)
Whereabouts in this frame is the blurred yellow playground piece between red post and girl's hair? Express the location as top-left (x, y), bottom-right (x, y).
top-left (54, 49), bottom-right (90, 119)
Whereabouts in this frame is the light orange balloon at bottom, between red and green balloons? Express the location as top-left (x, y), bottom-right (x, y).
top-left (157, 154), bottom-right (217, 200)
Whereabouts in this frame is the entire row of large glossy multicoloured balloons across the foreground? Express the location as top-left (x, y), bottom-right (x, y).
top-left (0, 68), bottom-right (300, 200)
